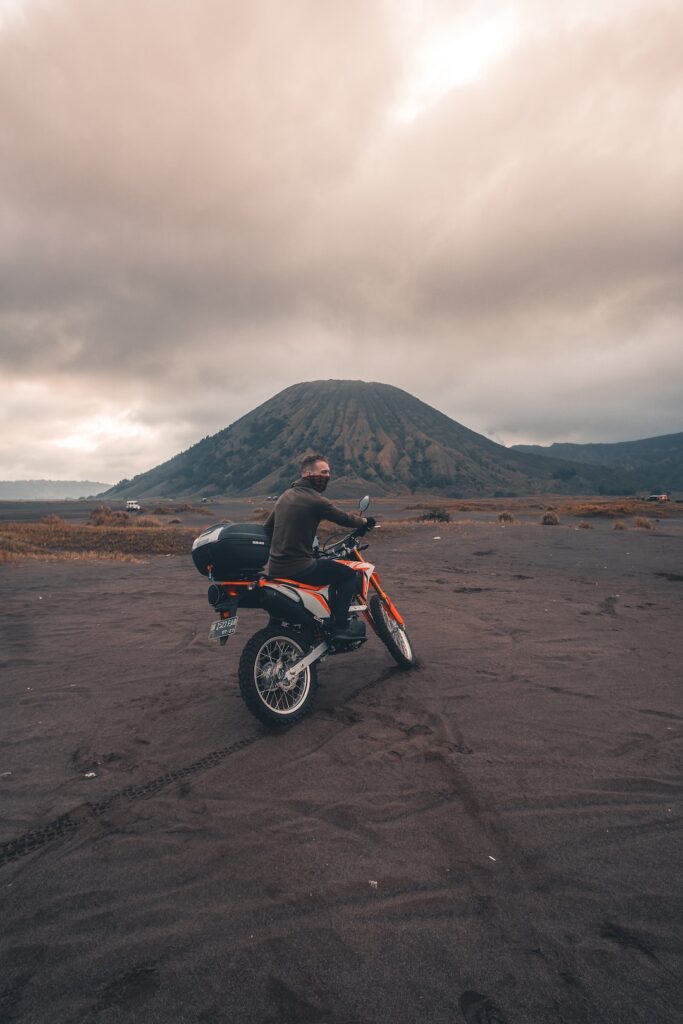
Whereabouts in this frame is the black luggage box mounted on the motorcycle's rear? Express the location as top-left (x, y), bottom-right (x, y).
top-left (193, 522), bottom-right (270, 581)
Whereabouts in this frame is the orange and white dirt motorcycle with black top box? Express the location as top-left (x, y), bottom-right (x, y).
top-left (193, 496), bottom-right (417, 726)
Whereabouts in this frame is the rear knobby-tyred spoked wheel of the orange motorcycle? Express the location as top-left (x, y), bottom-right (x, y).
top-left (239, 627), bottom-right (317, 726)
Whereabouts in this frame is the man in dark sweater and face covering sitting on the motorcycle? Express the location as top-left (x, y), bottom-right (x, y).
top-left (263, 455), bottom-right (375, 640)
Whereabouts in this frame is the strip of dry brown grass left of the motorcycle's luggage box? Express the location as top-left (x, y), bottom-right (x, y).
top-left (0, 516), bottom-right (197, 562)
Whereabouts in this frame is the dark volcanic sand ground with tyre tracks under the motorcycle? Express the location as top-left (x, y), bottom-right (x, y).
top-left (0, 522), bottom-right (683, 1024)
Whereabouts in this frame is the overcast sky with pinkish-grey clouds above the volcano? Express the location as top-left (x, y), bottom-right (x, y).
top-left (0, 0), bottom-right (683, 481)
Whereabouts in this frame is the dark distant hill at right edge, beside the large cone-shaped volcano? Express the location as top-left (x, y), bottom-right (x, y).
top-left (513, 433), bottom-right (683, 493)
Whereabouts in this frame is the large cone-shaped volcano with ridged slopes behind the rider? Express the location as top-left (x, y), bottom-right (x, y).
top-left (105, 380), bottom-right (609, 498)
